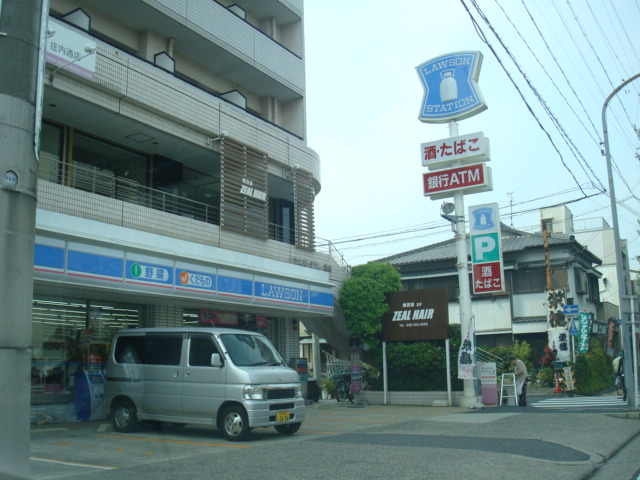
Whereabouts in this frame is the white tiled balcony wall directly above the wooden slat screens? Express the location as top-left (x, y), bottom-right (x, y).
top-left (48, 37), bottom-right (320, 182)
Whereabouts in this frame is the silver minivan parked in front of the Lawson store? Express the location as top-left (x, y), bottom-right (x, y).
top-left (104, 328), bottom-right (305, 441)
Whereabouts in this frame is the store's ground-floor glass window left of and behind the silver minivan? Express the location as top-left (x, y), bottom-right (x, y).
top-left (31, 297), bottom-right (142, 400)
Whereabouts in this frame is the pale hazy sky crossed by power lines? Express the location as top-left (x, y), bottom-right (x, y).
top-left (304, 0), bottom-right (640, 270)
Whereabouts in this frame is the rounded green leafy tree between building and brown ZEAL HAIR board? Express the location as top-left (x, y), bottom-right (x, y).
top-left (339, 262), bottom-right (402, 349)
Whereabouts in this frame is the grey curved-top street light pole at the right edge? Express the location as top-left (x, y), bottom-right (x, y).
top-left (602, 73), bottom-right (640, 409)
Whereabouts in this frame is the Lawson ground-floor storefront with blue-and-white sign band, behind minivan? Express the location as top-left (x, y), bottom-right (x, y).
top-left (31, 235), bottom-right (333, 421)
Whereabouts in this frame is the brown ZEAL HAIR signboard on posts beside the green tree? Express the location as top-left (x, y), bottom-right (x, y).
top-left (382, 288), bottom-right (449, 342)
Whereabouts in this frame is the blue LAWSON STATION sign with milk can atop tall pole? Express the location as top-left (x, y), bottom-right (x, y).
top-left (416, 52), bottom-right (487, 123)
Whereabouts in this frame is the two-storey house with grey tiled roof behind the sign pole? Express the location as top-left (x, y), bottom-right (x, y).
top-left (379, 218), bottom-right (606, 361)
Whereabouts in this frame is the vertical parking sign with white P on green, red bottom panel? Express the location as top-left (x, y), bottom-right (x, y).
top-left (469, 203), bottom-right (504, 293)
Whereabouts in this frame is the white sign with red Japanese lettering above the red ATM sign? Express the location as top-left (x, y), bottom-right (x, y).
top-left (420, 132), bottom-right (489, 170)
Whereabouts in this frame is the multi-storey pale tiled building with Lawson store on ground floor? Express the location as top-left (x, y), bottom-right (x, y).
top-left (31, 0), bottom-right (346, 418)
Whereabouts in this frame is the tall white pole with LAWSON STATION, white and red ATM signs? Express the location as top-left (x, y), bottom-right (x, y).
top-left (416, 52), bottom-right (491, 408)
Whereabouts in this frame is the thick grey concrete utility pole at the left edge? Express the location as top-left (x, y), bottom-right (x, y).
top-left (0, 0), bottom-right (47, 479)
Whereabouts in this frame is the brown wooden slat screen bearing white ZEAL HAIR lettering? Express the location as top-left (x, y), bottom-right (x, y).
top-left (220, 137), bottom-right (269, 239)
